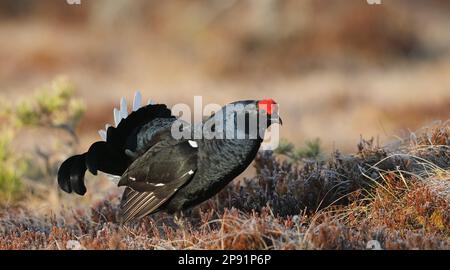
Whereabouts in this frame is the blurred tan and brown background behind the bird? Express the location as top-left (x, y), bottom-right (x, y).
top-left (0, 0), bottom-right (450, 209)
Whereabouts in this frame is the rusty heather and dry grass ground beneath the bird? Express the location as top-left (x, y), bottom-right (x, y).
top-left (0, 123), bottom-right (450, 249)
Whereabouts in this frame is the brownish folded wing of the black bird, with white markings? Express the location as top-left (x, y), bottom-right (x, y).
top-left (119, 134), bottom-right (197, 223)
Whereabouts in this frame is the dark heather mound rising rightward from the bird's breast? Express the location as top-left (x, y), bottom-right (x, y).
top-left (217, 123), bottom-right (450, 216)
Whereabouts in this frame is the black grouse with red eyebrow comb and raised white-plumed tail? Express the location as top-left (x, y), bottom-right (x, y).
top-left (57, 92), bottom-right (282, 224)
